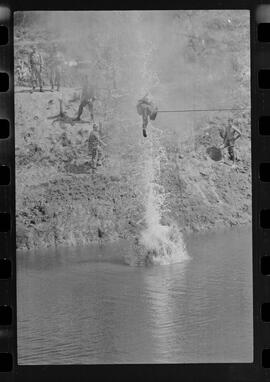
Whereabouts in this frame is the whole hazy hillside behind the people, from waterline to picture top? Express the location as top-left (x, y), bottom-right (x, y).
top-left (15, 10), bottom-right (251, 249)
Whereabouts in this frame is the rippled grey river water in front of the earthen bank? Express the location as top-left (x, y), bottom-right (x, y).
top-left (17, 229), bottom-right (253, 364)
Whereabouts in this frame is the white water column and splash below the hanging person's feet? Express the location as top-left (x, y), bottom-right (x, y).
top-left (140, 124), bottom-right (188, 264)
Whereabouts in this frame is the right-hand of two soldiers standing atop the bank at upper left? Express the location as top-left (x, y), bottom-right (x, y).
top-left (49, 44), bottom-right (65, 92)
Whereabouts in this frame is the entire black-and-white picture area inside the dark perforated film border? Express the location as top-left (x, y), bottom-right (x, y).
top-left (14, 9), bottom-right (253, 365)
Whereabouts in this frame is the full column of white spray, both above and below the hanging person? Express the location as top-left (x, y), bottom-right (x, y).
top-left (131, 13), bottom-right (188, 264)
